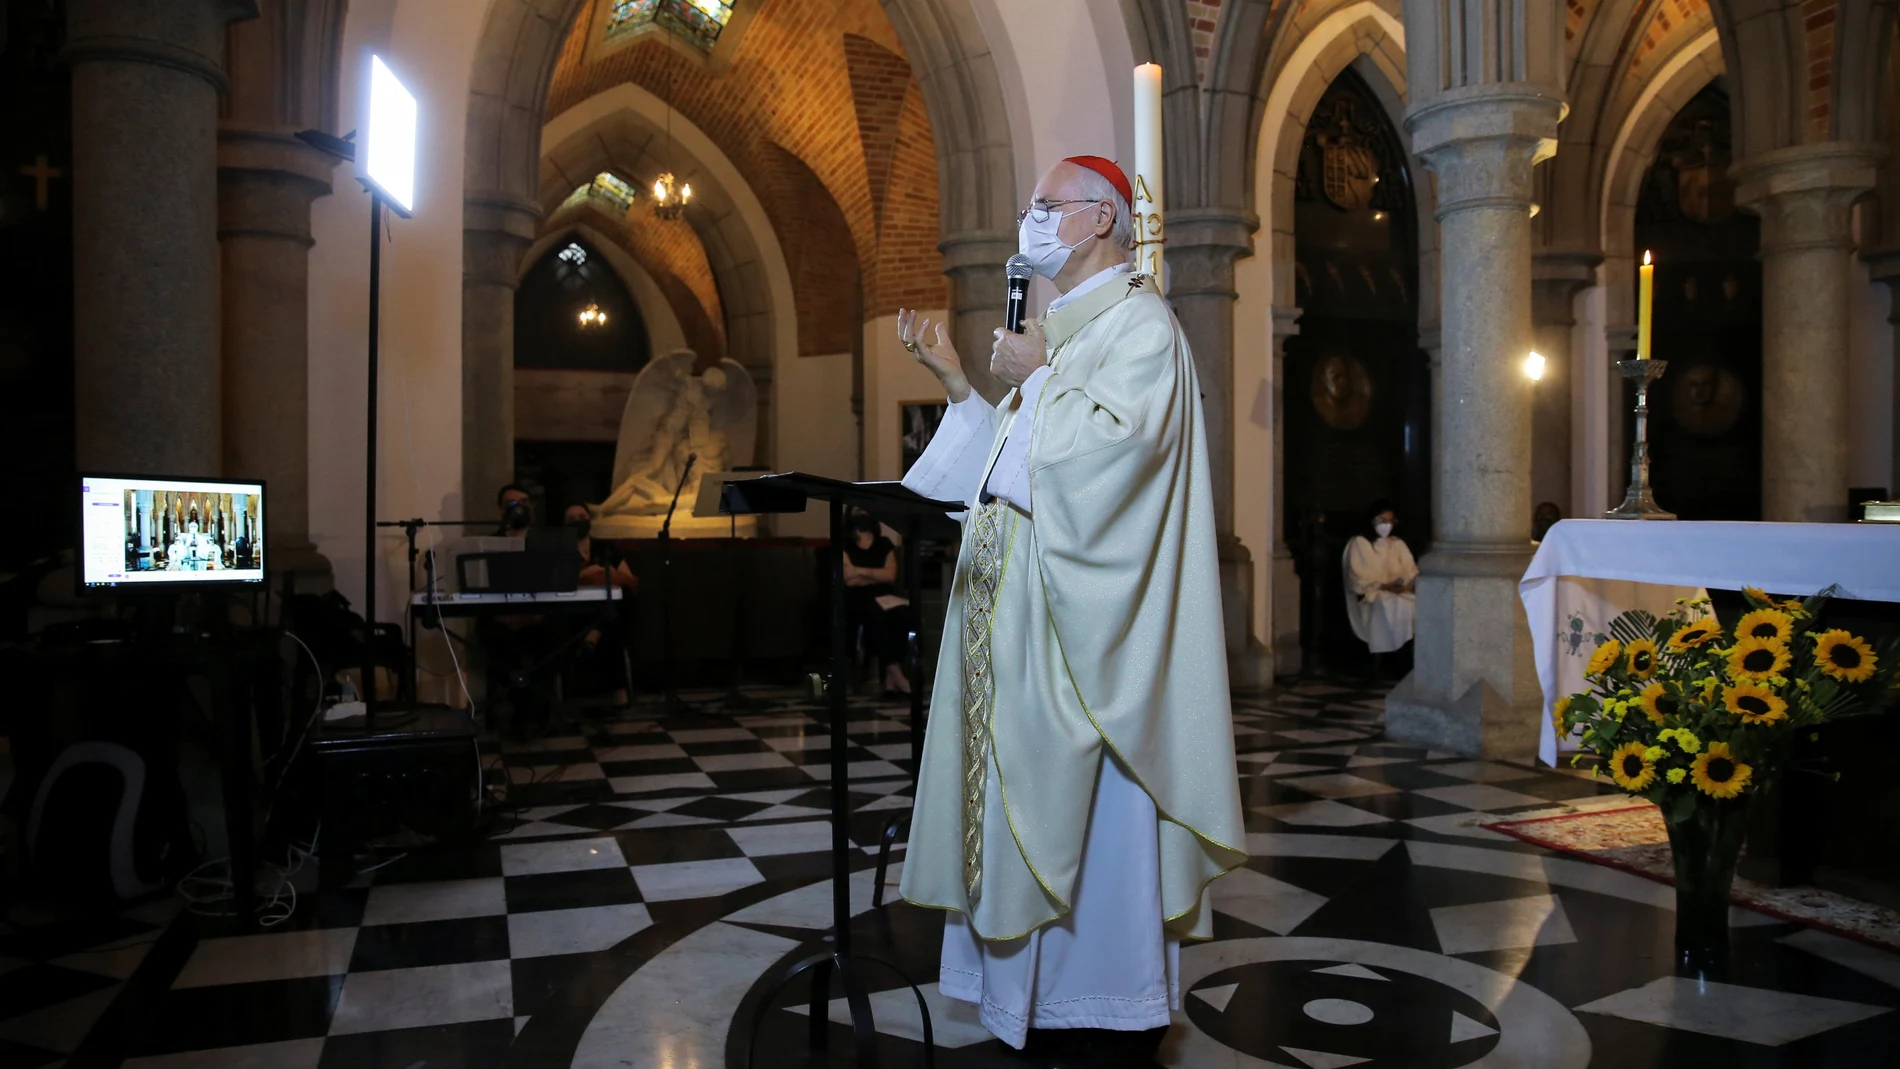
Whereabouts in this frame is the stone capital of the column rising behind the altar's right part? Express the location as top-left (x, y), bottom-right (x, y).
top-left (1729, 141), bottom-right (1885, 256)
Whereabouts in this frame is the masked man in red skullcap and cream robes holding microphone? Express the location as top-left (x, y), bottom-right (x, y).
top-left (899, 156), bottom-right (1246, 1069)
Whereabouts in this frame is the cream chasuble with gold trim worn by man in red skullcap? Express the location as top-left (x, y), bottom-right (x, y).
top-left (901, 275), bottom-right (1246, 1042)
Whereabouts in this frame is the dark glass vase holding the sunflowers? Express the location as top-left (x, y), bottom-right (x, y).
top-left (1663, 794), bottom-right (1754, 976)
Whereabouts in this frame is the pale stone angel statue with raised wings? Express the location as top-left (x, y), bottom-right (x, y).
top-left (591, 349), bottom-right (758, 537)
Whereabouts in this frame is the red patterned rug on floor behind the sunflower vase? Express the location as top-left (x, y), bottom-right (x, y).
top-left (1484, 801), bottom-right (1900, 951)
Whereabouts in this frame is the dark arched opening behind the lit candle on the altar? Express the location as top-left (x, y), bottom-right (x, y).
top-left (1625, 78), bottom-right (1761, 520)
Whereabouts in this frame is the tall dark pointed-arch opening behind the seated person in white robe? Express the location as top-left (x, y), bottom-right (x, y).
top-left (1281, 68), bottom-right (1431, 670)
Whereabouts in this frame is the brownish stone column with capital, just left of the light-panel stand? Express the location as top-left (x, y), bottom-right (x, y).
top-left (219, 127), bottom-right (336, 573)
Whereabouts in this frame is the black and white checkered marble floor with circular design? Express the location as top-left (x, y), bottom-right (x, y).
top-left (0, 685), bottom-right (1900, 1069)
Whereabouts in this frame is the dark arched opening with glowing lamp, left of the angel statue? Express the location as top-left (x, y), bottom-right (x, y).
top-left (515, 235), bottom-right (652, 518)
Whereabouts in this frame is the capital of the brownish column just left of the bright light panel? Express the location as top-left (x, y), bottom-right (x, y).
top-left (219, 127), bottom-right (338, 249)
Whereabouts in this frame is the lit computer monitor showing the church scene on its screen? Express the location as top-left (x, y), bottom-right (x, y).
top-left (78, 473), bottom-right (264, 591)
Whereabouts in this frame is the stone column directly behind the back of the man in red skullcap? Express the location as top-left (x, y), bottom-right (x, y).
top-left (1167, 209), bottom-right (1269, 687)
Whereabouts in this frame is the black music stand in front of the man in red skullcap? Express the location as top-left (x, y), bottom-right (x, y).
top-left (720, 473), bottom-right (963, 1069)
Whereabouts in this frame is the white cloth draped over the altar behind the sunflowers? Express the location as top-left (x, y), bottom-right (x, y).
top-left (1518, 520), bottom-right (1900, 765)
